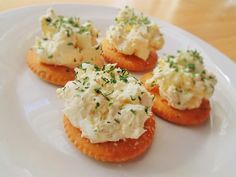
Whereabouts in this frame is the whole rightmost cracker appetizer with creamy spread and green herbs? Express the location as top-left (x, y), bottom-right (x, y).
top-left (141, 50), bottom-right (217, 125)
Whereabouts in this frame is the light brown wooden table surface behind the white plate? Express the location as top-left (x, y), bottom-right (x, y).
top-left (0, 0), bottom-right (236, 61)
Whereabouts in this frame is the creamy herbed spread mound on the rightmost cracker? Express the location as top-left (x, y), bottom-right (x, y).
top-left (146, 50), bottom-right (217, 110)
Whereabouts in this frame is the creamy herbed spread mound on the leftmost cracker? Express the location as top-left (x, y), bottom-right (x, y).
top-left (33, 9), bottom-right (101, 68)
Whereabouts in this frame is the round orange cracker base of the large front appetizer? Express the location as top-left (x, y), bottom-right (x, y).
top-left (64, 116), bottom-right (155, 163)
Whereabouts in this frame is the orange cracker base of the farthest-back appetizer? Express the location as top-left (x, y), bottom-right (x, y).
top-left (102, 40), bottom-right (157, 71)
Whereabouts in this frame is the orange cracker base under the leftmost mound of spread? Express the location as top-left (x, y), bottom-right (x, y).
top-left (27, 49), bottom-right (103, 86)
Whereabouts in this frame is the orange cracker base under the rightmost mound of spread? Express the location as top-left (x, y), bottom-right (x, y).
top-left (141, 73), bottom-right (211, 125)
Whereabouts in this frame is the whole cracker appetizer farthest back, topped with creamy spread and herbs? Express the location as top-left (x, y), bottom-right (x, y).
top-left (102, 6), bottom-right (164, 71)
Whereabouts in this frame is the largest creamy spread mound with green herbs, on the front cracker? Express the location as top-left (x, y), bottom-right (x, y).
top-left (57, 63), bottom-right (153, 143)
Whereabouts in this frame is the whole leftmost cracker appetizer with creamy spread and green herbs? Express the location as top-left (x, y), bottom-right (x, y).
top-left (27, 9), bottom-right (103, 86)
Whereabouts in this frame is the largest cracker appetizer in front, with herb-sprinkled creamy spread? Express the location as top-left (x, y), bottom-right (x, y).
top-left (57, 63), bottom-right (155, 162)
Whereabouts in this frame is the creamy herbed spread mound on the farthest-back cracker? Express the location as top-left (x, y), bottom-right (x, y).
top-left (106, 6), bottom-right (164, 60)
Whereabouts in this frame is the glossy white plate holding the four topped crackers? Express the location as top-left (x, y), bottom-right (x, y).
top-left (0, 4), bottom-right (236, 177)
